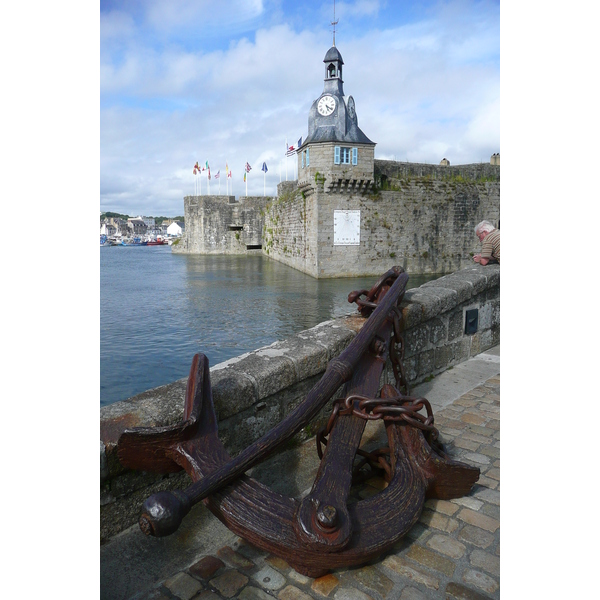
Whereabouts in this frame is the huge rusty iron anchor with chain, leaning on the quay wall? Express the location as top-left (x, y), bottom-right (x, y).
top-left (118, 267), bottom-right (479, 577)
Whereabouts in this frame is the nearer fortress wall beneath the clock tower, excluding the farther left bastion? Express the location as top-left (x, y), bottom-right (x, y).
top-left (263, 172), bottom-right (500, 278)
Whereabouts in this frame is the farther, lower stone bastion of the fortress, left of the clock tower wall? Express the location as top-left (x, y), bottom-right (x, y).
top-left (172, 196), bottom-right (273, 254)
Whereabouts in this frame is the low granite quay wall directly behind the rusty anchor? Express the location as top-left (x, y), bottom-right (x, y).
top-left (100, 264), bottom-right (500, 540)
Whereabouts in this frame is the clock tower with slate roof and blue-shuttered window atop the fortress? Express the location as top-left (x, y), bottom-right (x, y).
top-left (298, 43), bottom-right (375, 194)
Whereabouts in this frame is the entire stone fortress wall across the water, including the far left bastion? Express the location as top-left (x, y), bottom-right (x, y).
top-left (173, 160), bottom-right (500, 278)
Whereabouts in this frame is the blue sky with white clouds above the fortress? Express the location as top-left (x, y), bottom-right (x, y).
top-left (100, 0), bottom-right (500, 216)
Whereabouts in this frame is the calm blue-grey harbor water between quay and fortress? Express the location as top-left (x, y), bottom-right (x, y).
top-left (100, 246), bottom-right (437, 406)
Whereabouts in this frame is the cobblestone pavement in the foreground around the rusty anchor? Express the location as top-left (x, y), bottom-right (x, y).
top-left (132, 375), bottom-right (500, 600)
